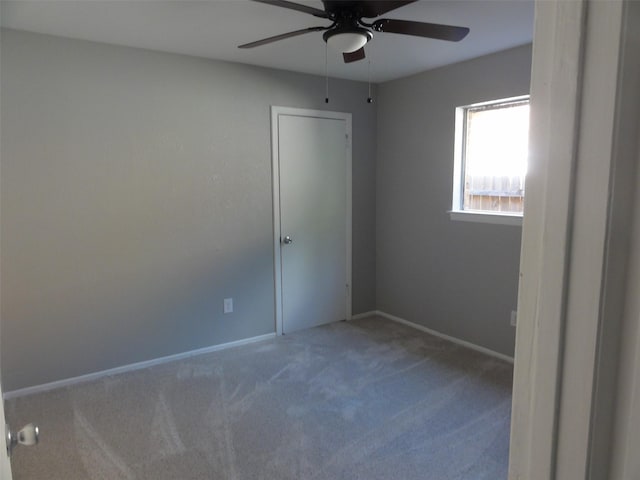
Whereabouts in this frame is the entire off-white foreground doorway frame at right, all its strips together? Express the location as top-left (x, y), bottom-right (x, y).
top-left (509, 0), bottom-right (640, 480)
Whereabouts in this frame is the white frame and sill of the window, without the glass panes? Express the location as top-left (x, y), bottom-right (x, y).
top-left (449, 95), bottom-right (530, 226)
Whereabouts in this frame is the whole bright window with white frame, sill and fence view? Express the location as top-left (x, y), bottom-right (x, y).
top-left (452, 97), bottom-right (529, 224)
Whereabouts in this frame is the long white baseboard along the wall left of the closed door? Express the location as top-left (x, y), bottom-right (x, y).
top-left (3, 332), bottom-right (276, 400)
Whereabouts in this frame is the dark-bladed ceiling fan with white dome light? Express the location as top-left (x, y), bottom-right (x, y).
top-left (238, 0), bottom-right (469, 63)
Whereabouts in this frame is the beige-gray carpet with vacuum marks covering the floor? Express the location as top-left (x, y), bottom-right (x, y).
top-left (6, 318), bottom-right (512, 480)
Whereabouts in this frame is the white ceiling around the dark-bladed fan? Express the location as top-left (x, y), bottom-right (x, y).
top-left (0, 0), bottom-right (533, 82)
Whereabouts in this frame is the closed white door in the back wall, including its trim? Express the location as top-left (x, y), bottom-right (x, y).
top-left (273, 107), bottom-right (351, 333)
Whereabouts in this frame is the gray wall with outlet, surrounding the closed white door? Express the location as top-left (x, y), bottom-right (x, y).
top-left (0, 30), bottom-right (376, 391)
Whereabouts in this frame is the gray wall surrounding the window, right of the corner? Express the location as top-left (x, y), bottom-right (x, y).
top-left (376, 46), bottom-right (531, 355)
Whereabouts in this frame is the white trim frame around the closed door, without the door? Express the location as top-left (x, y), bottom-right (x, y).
top-left (271, 105), bottom-right (353, 335)
